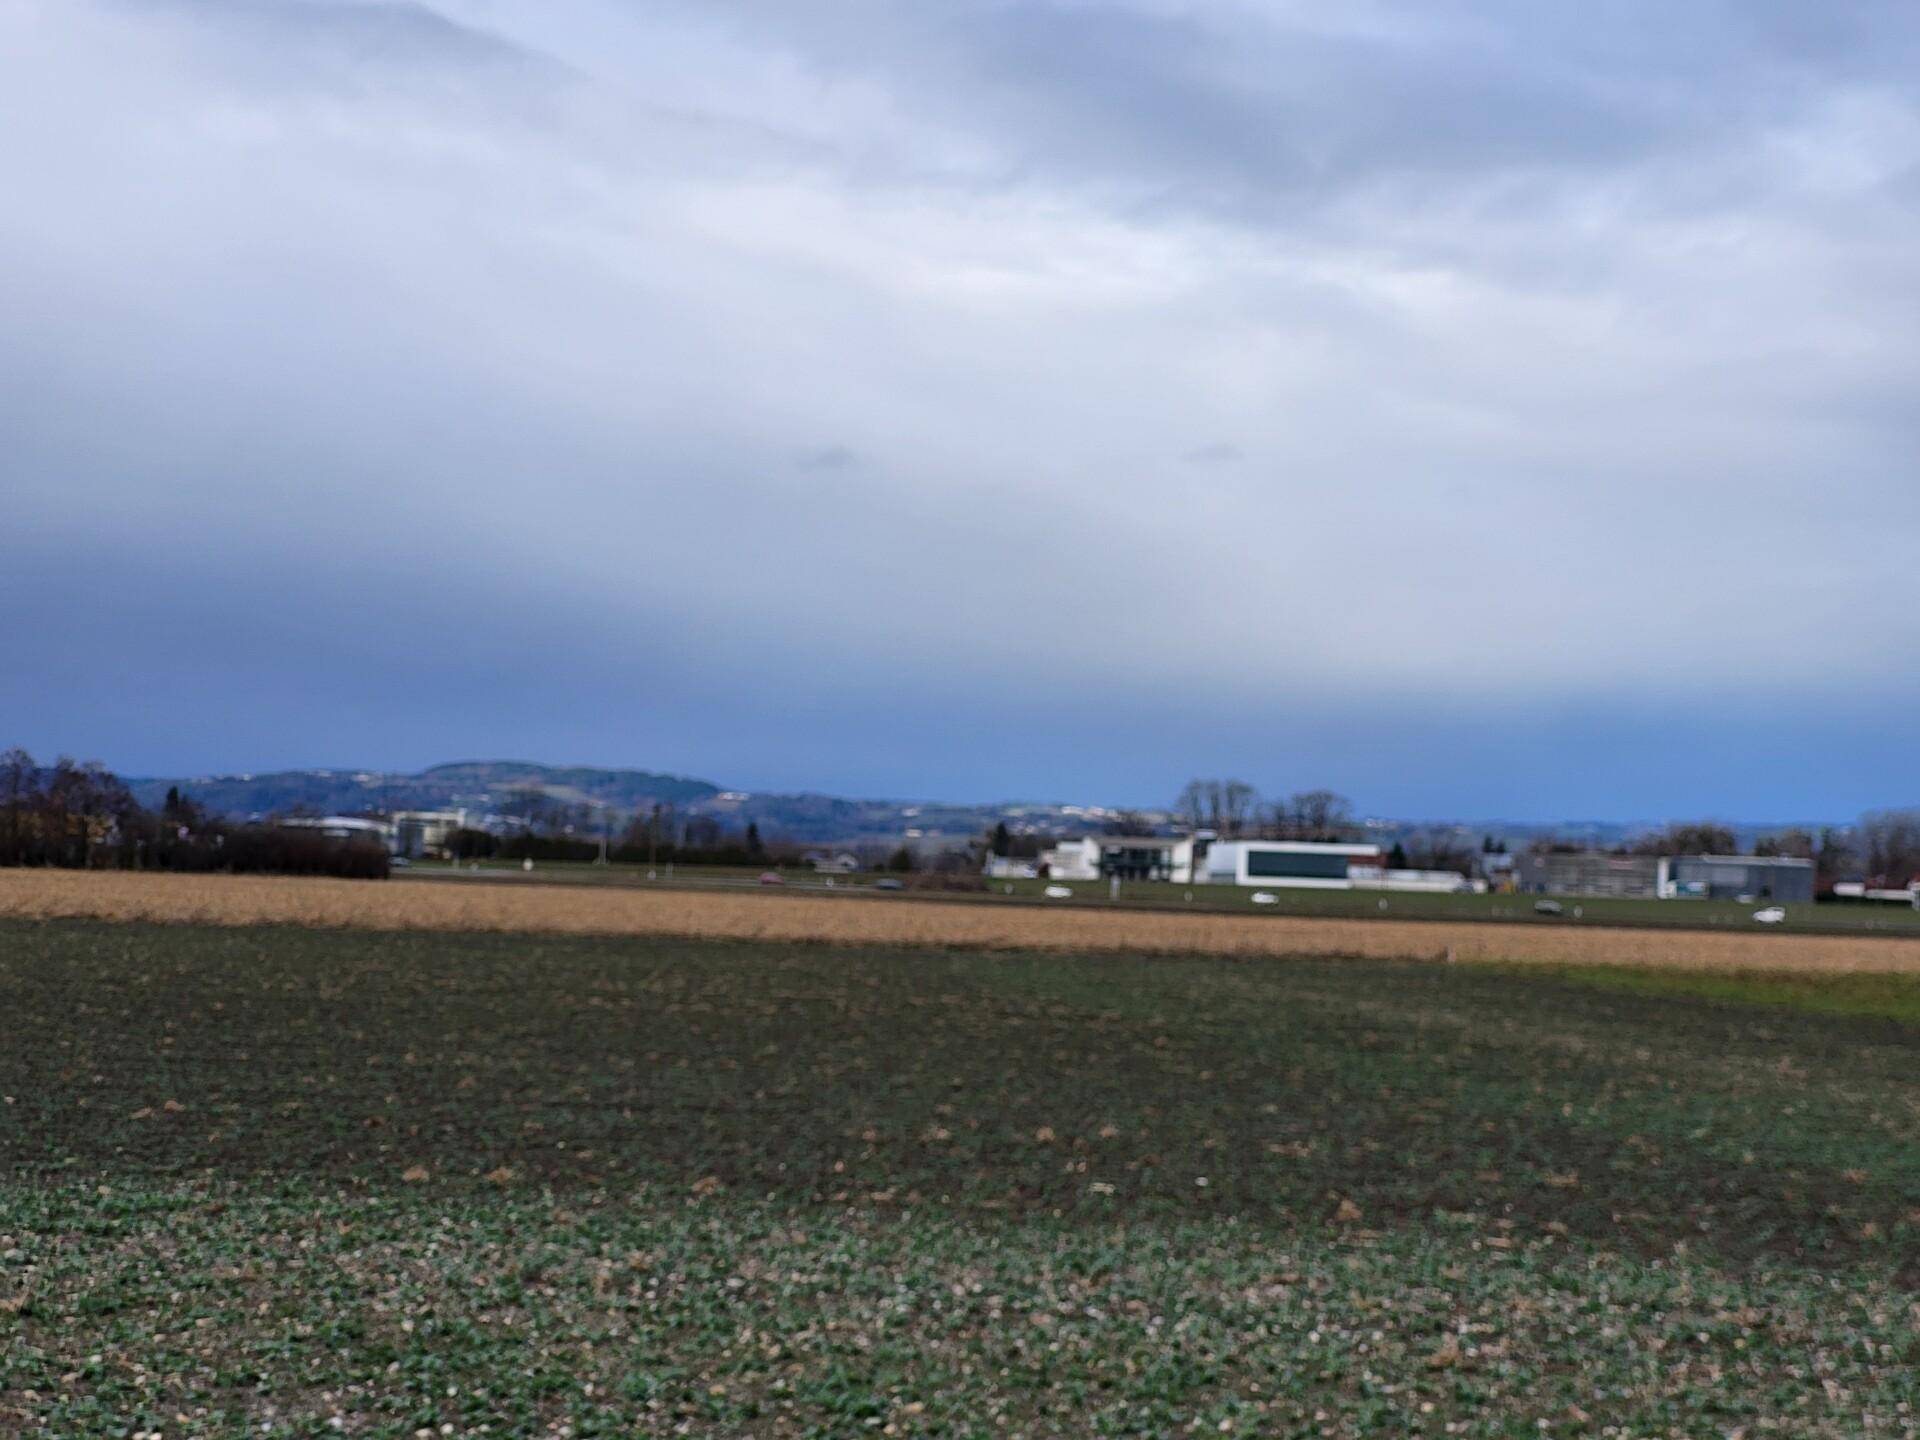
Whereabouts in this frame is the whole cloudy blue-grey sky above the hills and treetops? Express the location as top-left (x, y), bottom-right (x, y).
top-left (0, 0), bottom-right (1920, 818)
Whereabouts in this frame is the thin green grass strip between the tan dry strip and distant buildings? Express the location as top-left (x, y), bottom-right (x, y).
top-left (405, 860), bottom-right (1920, 935)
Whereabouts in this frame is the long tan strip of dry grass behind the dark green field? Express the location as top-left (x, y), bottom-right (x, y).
top-left (0, 870), bottom-right (1920, 973)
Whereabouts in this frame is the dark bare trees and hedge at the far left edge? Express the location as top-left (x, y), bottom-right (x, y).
top-left (0, 749), bottom-right (390, 879)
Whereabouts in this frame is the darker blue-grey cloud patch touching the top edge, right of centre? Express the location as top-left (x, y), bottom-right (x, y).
top-left (629, 0), bottom-right (1768, 211)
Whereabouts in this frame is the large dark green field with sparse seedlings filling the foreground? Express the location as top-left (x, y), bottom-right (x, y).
top-left (0, 922), bottom-right (1920, 1436)
